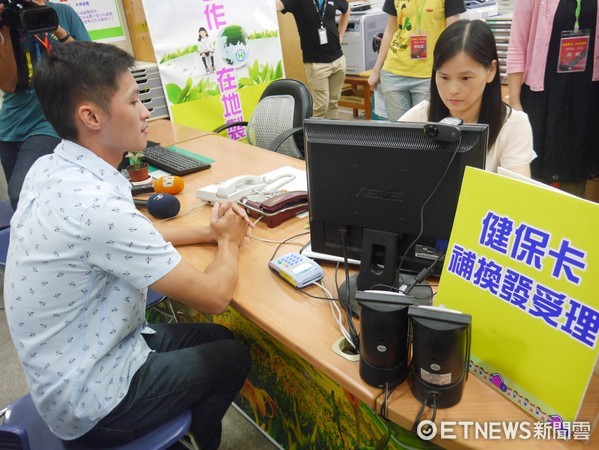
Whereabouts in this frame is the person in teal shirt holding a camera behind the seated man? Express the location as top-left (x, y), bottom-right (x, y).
top-left (0, 0), bottom-right (91, 209)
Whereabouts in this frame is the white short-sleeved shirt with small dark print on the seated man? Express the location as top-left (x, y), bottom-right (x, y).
top-left (4, 141), bottom-right (181, 439)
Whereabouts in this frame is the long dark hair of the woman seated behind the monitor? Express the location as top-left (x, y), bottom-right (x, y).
top-left (428, 20), bottom-right (509, 148)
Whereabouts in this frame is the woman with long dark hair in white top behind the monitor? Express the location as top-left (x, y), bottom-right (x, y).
top-left (399, 20), bottom-right (536, 177)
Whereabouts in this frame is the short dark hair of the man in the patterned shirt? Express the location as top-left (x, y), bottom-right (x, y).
top-left (33, 41), bottom-right (135, 141)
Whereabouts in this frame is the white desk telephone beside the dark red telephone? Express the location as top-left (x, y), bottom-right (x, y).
top-left (196, 173), bottom-right (295, 203)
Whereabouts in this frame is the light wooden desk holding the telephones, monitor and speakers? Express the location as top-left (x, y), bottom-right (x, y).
top-left (150, 124), bottom-right (599, 449)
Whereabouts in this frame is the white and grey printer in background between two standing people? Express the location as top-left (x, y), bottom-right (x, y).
top-left (341, 8), bottom-right (387, 75)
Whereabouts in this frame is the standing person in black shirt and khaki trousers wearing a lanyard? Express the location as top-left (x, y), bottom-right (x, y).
top-left (276, 0), bottom-right (349, 119)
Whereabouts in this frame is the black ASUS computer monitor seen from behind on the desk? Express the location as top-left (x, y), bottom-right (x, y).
top-left (304, 118), bottom-right (488, 296)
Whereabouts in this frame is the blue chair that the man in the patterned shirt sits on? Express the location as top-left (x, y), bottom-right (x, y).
top-left (0, 395), bottom-right (198, 450)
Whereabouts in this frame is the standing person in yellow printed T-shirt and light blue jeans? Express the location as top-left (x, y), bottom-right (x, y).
top-left (368, 0), bottom-right (466, 121)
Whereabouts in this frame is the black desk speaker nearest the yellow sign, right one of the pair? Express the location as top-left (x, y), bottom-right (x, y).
top-left (408, 306), bottom-right (472, 408)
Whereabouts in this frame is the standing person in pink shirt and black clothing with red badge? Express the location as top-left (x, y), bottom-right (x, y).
top-left (507, 0), bottom-right (599, 196)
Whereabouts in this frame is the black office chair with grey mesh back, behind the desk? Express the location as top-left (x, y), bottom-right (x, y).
top-left (214, 78), bottom-right (312, 159)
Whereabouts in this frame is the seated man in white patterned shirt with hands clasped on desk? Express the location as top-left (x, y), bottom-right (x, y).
top-left (5, 42), bottom-right (250, 449)
